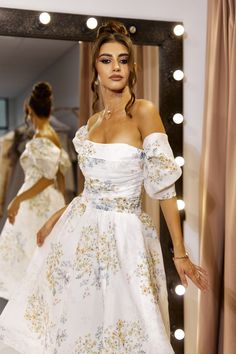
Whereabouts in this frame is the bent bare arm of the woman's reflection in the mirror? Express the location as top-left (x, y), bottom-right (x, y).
top-left (7, 177), bottom-right (54, 224)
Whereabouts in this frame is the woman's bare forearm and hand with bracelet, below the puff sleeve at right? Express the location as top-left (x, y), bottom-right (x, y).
top-left (160, 197), bottom-right (208, 291)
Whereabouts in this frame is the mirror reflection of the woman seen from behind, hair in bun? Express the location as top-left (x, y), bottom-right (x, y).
top-left (0, 82), bottom-right (70, 299)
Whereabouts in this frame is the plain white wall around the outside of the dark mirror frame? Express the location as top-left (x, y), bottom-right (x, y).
top-left (1, 0), bottom-right (207, 354)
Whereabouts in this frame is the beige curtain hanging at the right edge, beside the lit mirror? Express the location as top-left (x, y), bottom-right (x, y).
top-left (197, 0), bottom-right (236, 354)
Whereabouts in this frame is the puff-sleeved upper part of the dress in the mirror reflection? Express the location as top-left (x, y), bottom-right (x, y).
top-left (20, 137), bottom-right (71, 185)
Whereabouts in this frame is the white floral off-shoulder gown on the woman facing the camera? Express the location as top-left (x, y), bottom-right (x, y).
top-left (0, 126), bottom-right (181, 354)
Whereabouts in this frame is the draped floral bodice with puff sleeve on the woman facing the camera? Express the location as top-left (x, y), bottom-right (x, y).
top-left (73, 126), bottom-right (181, 212)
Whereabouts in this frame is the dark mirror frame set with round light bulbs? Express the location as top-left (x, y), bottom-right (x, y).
top-left (0, 7), bottom-right (184, 354)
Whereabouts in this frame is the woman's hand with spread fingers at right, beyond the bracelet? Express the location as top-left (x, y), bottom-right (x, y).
top-left (173, 257), bottom-right (209, 291)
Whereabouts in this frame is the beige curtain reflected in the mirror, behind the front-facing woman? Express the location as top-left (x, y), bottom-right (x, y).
top-left (78, 42), bottom-right (159, 227)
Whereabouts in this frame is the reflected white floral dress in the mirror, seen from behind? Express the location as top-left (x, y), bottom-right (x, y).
top-left (0, 138), bottom-right (70, 299)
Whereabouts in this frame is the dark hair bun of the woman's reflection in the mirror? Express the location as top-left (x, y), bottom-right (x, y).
top-left (29, 82), bottom-right (52, 118)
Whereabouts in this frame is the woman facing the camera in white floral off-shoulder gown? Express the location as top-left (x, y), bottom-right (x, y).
top-left (1, 22), bottom-right (207, 354)
